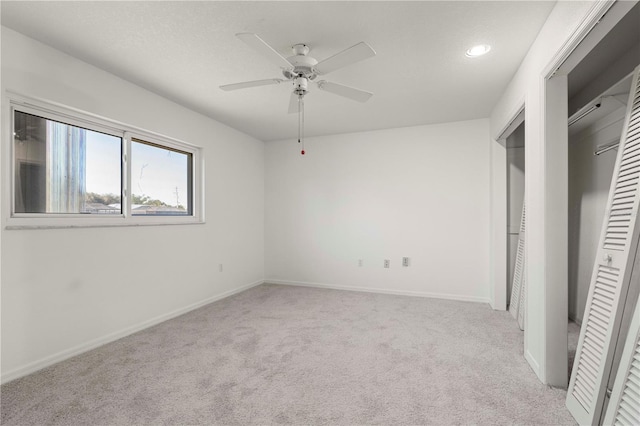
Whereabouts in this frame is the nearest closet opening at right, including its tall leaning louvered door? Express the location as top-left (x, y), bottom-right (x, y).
top-left (566, 3), bottom-right (640, 424)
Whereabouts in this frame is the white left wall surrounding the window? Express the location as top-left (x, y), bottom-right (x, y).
top-left (0, 27), bottom-right (264, 381)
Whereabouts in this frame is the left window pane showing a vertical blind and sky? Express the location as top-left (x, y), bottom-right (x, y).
top-left (13, 110), bottom-right (122, 214)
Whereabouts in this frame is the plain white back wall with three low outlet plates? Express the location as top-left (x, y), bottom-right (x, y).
top-left (265, 120), bottom-right (490, 302)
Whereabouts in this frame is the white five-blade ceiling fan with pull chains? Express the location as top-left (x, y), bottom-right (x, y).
top-left (220, 33), bottom-right (376, 155)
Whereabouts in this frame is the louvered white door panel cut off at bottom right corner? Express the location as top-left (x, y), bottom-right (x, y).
top-left (603, 297), bottom-right (640, 426)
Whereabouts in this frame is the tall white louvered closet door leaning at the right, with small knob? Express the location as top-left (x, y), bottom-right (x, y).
top-left (567, 67), bottom-right (640, 425)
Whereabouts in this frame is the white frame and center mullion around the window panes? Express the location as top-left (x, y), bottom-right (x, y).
top-left (2, 92), bottom-right (204, 229)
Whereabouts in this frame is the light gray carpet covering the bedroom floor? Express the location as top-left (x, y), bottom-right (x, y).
top-left (1, 284), bottom-right (575, 425)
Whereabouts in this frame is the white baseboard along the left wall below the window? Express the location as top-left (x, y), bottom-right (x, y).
top-left (0, 280), bottom-right (264, 384)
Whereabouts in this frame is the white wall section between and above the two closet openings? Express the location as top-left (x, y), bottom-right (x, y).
top-left (490, 1), bottom-right (605, 386)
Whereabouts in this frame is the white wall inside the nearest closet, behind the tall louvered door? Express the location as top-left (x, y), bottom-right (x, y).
top-left (569, 107), bottom-right (625, 323)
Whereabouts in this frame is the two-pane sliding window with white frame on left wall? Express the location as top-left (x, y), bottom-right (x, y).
top-left (8, 94), bottom-right (203, 228)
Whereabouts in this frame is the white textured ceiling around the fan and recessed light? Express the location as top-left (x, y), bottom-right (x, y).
top-left (0, 0), bottom-right (555, 141)
